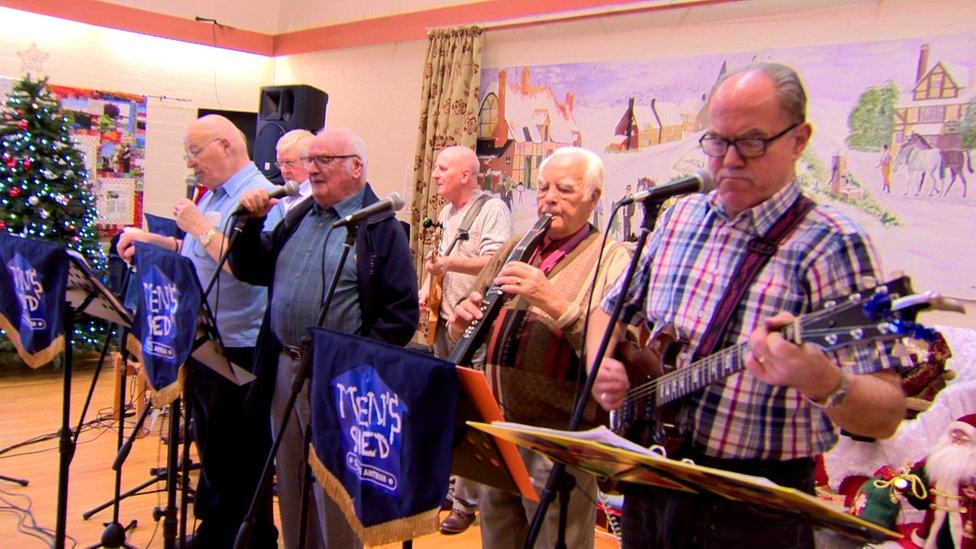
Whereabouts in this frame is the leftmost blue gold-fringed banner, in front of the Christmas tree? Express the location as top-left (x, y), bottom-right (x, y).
top-left (0, 234), bottom-right (68, 368)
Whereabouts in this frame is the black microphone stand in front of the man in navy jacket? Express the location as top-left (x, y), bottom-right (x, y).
top-left (234, 221), bottom-right (359, 549)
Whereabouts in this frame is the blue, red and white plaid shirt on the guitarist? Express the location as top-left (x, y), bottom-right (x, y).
top-left (603, 182), bottom-right (901, 460)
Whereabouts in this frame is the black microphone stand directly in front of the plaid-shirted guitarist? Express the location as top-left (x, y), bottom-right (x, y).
top-left (523, 200), bottom-right (661, 549)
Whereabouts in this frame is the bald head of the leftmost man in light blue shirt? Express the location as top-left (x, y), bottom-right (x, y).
top-left (183, 114), bottom-right (251, 189)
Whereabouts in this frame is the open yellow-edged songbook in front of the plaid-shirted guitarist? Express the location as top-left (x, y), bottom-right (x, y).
top-left (469, 422), bottom-right (902, 543)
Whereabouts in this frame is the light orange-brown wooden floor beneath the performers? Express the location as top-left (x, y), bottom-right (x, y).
top-left (0, 364), bottom-right (617, 549)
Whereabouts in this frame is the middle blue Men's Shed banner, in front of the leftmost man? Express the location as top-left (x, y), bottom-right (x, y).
top-left (128, 242), bottom-right (202, 406)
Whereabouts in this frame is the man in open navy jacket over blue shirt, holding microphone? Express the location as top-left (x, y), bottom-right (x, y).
top-left (230, 129), bottom-right (419, 548)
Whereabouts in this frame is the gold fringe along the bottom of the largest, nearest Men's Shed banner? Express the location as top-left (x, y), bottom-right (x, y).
top-left (308, 444), bottom-right (440, 545)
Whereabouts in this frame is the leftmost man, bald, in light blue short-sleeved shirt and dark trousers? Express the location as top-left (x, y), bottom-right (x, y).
top-left (118, 115), bottom-right (281, 547)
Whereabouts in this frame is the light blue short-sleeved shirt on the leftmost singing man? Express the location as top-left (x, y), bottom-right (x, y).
top-left (180, 163), bottom-right (281, 347)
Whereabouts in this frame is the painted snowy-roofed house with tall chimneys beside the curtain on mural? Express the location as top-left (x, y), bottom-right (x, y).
top-left (478, 67), bottom-right (583, 192)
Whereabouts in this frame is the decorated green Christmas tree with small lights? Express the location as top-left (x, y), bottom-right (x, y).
top-left (0, 74), bottom-right (108, 344)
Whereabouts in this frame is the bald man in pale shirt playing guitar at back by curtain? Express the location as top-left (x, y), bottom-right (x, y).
top-left (418, 146), bottom-right (512, 534)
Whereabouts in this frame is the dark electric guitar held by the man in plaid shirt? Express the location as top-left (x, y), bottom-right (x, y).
top-left (610, 277), bottom-right (961, 452)
